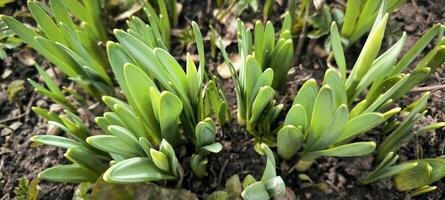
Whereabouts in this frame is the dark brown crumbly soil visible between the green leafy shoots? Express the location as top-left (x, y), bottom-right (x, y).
top-left (0, 0), bottom-right (445, 200)
